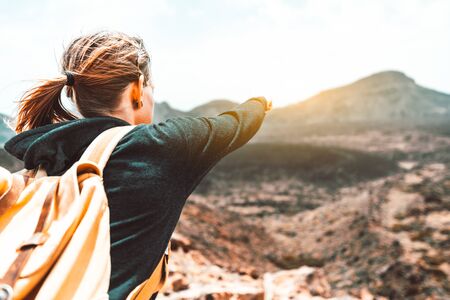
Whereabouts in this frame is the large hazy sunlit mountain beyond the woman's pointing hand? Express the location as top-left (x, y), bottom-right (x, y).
top-left (246, 71), bottom-right (450, 142)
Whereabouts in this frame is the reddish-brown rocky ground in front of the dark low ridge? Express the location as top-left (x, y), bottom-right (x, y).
top-left (159, 130), bottom-right (450, 299)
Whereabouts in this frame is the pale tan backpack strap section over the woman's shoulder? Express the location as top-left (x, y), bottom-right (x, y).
top-left (80, 125), bottom-right (137, 174)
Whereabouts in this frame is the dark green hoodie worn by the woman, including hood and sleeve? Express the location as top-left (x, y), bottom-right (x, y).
top-left (5, 98), bottom-right (266, 299)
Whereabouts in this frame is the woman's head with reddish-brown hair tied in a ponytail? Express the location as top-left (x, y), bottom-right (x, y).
top-left (15, 30), bottom-right (153, 133)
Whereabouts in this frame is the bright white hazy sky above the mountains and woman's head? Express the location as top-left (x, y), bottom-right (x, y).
top-left (0, 0), bottom-right (450, 114)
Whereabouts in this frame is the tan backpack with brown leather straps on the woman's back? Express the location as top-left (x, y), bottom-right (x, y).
top-left (0, 125), bottom-right (170, 300)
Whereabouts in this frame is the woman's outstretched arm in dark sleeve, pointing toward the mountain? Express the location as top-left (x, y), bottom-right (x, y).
top-left (137, 97), bottom-right (271, 194)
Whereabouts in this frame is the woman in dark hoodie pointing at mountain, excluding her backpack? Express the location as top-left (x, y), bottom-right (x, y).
top-left (5, 31), bottom-right (272, 299)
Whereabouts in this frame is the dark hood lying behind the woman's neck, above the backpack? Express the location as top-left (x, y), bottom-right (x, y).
top-left (4, 116), bottom-right (131, 176)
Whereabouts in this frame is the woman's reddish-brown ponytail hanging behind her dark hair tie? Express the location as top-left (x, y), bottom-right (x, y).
top-left (15, 76), bottom-right (78, 133)
